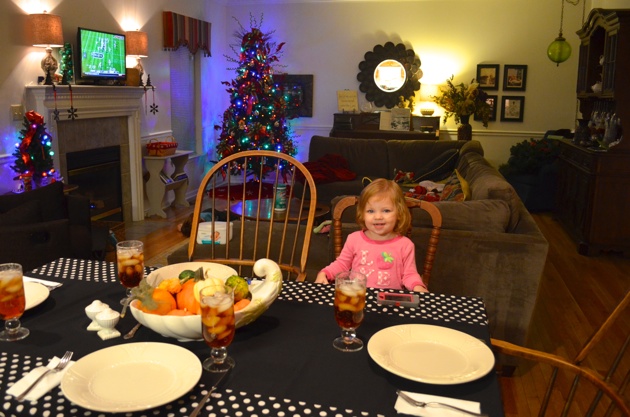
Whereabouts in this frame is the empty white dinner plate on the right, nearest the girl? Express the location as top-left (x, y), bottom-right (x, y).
top-left (368, 324), bottom-right (494, 385)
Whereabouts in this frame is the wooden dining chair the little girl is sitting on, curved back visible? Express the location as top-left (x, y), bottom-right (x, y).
top-left (332, 196), bottom-right (442, 288)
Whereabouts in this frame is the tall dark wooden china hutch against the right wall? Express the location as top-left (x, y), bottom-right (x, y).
top-left (555, 9), bottom-right (630, 256)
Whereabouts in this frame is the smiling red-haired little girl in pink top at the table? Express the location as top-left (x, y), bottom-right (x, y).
top-left (315, 178), bottom-right (428, 292)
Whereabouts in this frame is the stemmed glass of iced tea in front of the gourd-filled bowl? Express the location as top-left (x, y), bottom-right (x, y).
top-left (199, 285), bottom-right (236, 372)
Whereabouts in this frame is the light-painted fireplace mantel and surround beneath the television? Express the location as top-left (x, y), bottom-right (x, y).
top-left (25, 85), bottom-right (145, 221)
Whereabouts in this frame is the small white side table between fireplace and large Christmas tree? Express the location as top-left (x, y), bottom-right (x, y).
top-left (143, 151), bottom-right (193, 218)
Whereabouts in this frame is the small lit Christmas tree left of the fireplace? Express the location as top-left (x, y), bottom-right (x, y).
top-left (11, 111), bottom-right (55, 181)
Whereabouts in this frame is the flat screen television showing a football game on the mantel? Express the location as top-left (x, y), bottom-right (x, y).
top-left (77, 27), bottom-right (127, 84)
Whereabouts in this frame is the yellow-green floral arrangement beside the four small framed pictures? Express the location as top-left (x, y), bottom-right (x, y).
top-left (432, 75), bottom-right (492, 127)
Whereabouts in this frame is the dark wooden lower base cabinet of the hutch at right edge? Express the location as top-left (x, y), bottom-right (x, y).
top-left (556, 140), bottom-right (630, 256)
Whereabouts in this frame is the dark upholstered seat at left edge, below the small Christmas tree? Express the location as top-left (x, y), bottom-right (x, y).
top-left (0, 182), bottom-right (92, 271)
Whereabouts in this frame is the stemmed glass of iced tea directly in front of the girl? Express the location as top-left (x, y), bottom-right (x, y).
top-left (333, 271), bottom-right (367, 352)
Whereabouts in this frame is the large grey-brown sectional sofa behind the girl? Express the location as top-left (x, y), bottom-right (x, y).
top-left (308, 136), bottom-right (548, 345)
